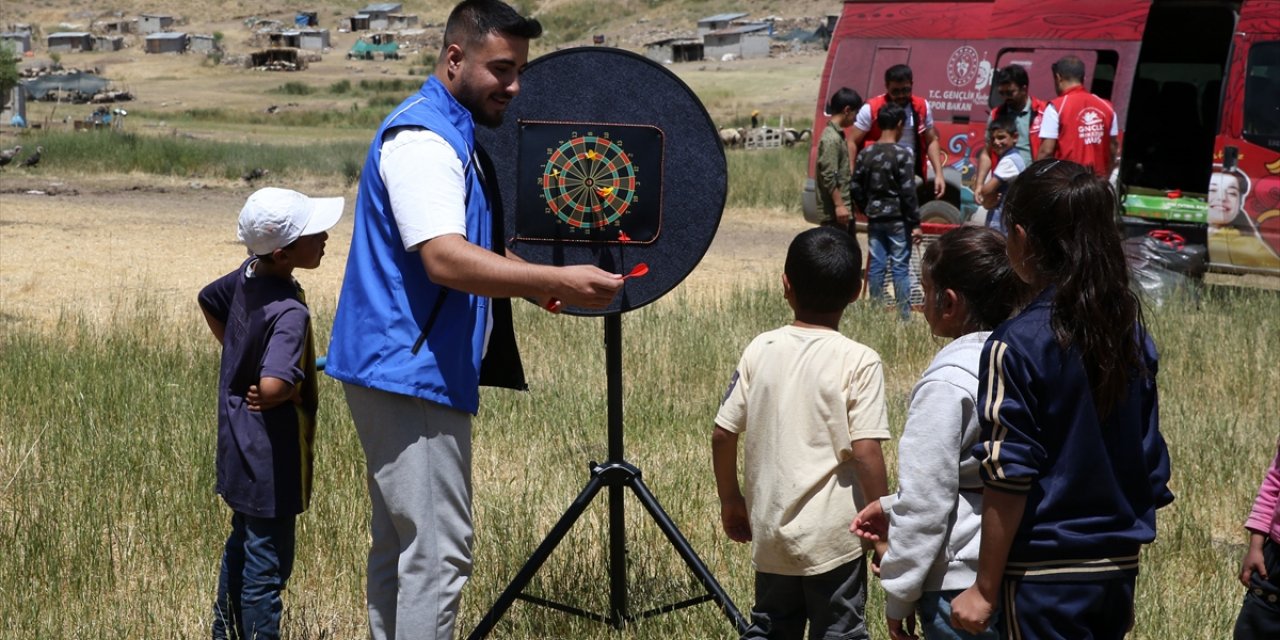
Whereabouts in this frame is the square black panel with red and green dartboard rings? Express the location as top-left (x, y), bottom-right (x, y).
top-left (515, 120), bottom-right (663, 244)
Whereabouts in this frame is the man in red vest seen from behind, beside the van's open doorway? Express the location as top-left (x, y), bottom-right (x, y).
top-left (1036, 55), bottom-right (1120, 178)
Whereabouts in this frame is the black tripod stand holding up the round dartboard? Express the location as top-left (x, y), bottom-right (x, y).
top-left (467, 314), bottom-right (746, 640)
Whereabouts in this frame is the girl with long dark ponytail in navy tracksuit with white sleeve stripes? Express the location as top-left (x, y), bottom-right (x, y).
top-left (951, 160), bottom-right (1174, 640)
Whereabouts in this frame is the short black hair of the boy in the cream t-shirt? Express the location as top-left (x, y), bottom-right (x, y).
top-left (783, 227), bottom-right (863, 314)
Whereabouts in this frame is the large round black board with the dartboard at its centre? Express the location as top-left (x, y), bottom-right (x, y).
top-left (475, 46), bottom-right (728, 315)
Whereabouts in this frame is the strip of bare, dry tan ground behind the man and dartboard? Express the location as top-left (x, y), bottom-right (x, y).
top-left (0, 177), bottom-right (806, 328)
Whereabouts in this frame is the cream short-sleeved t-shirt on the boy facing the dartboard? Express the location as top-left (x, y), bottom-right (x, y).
top-left (716, 325), bottom-right (890, 576)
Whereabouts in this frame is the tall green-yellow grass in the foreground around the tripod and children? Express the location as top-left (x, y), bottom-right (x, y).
top-left (0, 273), bottom-right (1280, 639)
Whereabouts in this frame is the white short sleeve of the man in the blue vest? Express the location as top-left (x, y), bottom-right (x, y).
top-left (379, 128), bottom-right (467, 251)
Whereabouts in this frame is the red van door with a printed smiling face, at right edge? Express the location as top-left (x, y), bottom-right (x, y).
top-left (1207, 12), bottom-right (1280, 276)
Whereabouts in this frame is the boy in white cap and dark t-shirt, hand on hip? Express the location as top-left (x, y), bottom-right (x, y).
top-left (198, 187), bottom-right (343, 640)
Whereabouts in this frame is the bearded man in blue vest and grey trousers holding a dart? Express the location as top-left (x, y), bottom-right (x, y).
top-left (326, 0), bottom-right (622, 640)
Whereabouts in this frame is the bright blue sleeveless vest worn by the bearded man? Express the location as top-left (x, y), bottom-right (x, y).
top-left (325, 76), bottom-right (494, 413)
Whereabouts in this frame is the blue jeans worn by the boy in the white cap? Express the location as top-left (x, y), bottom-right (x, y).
top-left (214, 513), bottom-right (296, 640)
